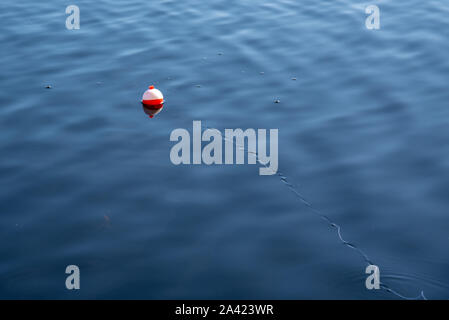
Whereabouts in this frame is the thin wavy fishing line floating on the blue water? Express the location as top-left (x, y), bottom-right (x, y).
top-left (205, 124), bottom-right (427, 300)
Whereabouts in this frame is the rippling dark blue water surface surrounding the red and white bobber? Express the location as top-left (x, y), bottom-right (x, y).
top-left (0, 0), bottom-right (449, 299)
